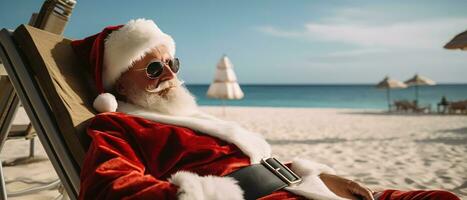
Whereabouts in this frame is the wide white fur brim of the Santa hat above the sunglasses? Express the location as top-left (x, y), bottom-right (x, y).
top-left (102, 19), bottom-right (175, 90)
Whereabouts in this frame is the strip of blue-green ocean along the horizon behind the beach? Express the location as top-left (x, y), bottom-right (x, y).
top-left (187, 84), bottom-right (467, 110)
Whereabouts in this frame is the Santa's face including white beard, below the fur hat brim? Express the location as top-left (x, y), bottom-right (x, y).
top-left (116, 45), bottom-right (196, 115)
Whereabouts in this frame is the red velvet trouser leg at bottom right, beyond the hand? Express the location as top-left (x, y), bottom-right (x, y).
top-left (378, 190), bottom-right (460, 200)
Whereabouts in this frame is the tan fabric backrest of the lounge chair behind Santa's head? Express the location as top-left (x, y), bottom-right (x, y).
top-left (13, 25), bottom-right (96, 166)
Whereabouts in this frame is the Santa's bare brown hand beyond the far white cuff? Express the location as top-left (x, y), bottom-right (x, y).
top-left (319, 174), bottom-right (374, 200)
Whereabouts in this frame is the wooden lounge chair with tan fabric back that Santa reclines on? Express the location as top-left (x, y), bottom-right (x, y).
top-left (0, 25), bottom-right (96, 199)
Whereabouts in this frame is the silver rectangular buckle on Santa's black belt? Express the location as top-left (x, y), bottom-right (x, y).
top-left (261, 157), bottom-right (302, 186)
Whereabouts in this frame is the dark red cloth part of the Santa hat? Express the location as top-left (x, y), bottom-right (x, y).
top-left (71, 25), bottom-right (123, 93)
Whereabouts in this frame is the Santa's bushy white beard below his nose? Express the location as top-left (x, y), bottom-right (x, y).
top-left (126, 78), bottom-right (198, 116)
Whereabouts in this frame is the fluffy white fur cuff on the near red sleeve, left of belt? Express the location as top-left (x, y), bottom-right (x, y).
top-left (169, 171), bottom-right (247, 200)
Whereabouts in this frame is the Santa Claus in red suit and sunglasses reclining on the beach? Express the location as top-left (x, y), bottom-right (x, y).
top-left (72, 19), bottom-right (458, 200)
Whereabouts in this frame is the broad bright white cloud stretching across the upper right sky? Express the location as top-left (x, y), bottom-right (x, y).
top-left (258, 18), bottom-right (467, 48)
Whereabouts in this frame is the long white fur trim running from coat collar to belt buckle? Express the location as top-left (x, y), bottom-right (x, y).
top-left (118, 101), bottom-right (271, 164)
